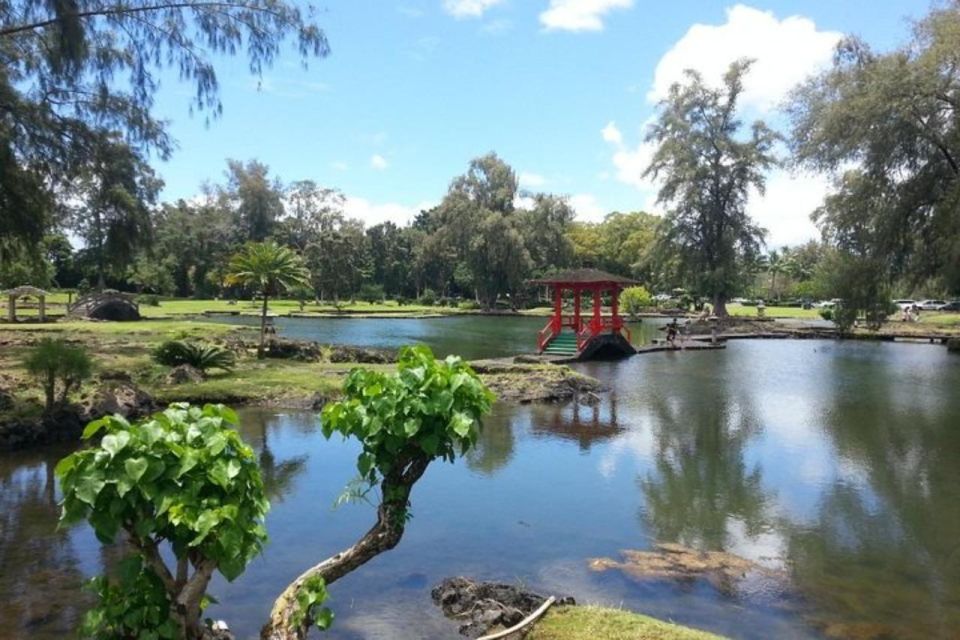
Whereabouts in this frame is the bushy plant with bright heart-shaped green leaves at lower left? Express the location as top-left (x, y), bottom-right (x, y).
top-left (56, 404), bottom-right (269, 640)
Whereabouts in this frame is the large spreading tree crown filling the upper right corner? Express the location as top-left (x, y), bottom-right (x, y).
top-left (788, 5), bottom-right (960, 293)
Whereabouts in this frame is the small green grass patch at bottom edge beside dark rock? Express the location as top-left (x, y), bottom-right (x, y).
top-left (527, 606), bottom-right (722, 640)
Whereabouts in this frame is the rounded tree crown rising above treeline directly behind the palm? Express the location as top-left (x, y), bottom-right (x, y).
top-left (220, 160), bottom-right (283, 242)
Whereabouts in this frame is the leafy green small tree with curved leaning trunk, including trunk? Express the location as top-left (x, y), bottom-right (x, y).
top-left (261, 346), bottom-right (494, 640)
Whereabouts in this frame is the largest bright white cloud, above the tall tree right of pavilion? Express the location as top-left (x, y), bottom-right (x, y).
top-left (647, 4), bottom-right (843, 112)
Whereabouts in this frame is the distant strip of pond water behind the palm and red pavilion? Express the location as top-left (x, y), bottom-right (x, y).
top-left (201, 315), bottom-right (669, 359)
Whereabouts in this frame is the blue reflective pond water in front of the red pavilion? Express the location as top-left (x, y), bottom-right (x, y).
top-left (0, 330), bottom-right (960, 640)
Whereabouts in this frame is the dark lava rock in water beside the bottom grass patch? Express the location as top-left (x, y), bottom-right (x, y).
top-left (430, 577), bottom-right (576, 638)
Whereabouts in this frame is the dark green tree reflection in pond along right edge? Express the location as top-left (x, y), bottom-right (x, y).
top-left (788, 348), bottom-right (960, 639)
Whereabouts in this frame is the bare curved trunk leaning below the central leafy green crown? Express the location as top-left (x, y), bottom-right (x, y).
top-left (260, 458), bottom-right (430, 640)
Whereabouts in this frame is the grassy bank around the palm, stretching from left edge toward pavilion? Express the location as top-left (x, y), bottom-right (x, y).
top-left (0, 318), bottom-right (599, 414)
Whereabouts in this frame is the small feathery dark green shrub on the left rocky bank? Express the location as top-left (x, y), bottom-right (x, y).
top-left (23, 338), bottom-right (93, 411)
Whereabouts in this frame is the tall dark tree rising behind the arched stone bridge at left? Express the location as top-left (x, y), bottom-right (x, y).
top-left (69, 135), bottom-right (163, 289)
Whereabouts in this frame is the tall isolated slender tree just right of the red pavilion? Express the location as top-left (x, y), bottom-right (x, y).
top-left (644, 60), bottom-right (777, 316)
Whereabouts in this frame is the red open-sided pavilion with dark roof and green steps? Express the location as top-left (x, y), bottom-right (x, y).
top-left (530, 269), bottom-right (637, 360)
